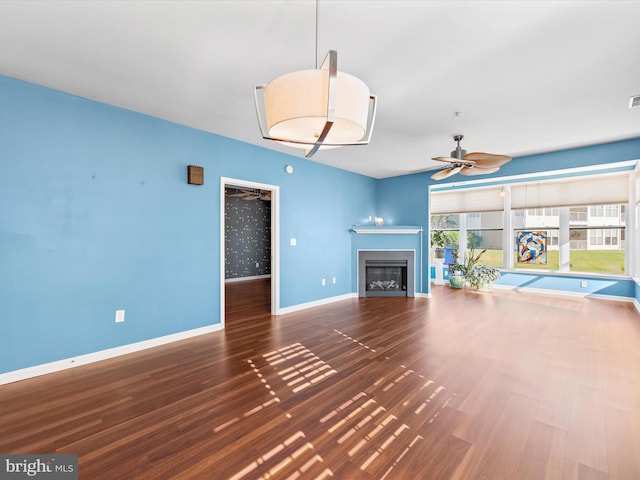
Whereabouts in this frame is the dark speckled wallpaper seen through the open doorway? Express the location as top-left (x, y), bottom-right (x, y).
top-left (224, 187), bottom-right (271, 279)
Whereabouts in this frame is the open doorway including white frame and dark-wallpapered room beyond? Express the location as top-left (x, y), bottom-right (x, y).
top-left (220, 177), bottom-right (280, 328)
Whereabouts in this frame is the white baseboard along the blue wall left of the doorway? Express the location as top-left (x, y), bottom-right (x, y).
top-left (0, 323), bottom-right (222, 385)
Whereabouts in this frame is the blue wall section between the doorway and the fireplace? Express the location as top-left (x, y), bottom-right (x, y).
top-left (280, 159), bottom-right (376, 307)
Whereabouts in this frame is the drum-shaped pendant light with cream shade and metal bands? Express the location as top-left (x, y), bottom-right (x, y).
top-left (255, 0), bottom-right (377, 158)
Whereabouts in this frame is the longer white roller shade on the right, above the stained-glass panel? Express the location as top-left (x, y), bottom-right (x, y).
top-left (511, 173), bottom-right (629, 209)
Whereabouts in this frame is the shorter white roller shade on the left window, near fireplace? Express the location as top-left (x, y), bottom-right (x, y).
top-left (431, 185), bottom-right (504, 214)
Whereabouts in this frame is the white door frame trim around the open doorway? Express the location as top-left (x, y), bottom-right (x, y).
top-left (220, 177), bottom-right (280, 328)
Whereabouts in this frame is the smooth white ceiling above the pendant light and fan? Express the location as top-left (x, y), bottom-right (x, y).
top-left (0, 0), bottom-right (640, 178)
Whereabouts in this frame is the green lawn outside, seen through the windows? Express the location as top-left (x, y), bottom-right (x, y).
top-left (432, 250), bottom-right (624, 275)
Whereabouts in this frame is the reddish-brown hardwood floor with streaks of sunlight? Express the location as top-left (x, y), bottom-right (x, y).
top-left (0, 280), bottom-right (640, 480)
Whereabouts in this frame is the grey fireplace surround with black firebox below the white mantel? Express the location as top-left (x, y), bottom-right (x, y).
top-left (358, 250), bottom-right (415, 297)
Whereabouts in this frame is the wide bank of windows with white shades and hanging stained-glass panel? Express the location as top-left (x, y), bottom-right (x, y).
top-left (430, 167), bottom-right (640, 275)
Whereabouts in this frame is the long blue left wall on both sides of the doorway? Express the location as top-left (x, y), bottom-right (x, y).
top-left (0, 76), bottom-right (375, 373)
